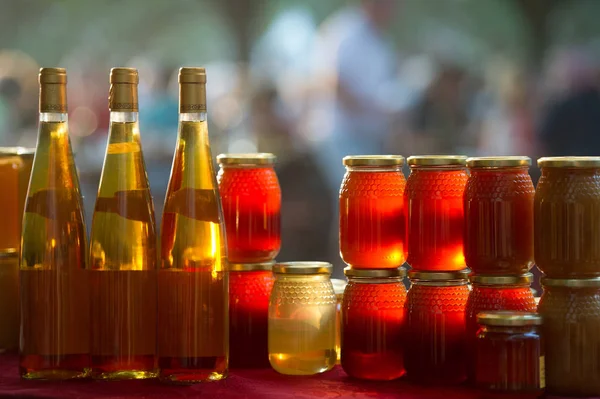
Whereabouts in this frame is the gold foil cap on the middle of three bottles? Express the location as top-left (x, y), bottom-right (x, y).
top-left (108, 68), bottom-right (139, 112)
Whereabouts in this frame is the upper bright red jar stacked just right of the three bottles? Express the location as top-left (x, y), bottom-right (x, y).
top-left (217, 153), bottom-right (281, 263)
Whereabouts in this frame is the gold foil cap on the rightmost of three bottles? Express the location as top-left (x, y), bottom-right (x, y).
top-left (179, 68), bottom-right (206, 114)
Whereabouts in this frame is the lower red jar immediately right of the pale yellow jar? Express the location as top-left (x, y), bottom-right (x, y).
top-left (341, 268), bottom-right (406, 381)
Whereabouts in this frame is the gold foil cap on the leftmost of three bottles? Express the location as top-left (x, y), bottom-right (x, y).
top-left (38, 68), bottom-right (67, 113)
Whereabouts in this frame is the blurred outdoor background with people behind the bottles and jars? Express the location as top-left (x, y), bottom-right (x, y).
top-left (0, 0), bottom-right (600, 275)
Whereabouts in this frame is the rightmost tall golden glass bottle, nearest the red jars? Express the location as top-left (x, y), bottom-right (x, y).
top-left (158, 68), bottom-right (229, 383)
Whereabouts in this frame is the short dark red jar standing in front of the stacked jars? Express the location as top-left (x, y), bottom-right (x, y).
top-left (475, 311), bottom-right (545, 399)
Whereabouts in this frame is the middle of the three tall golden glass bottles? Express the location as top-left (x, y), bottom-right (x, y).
top-left (90, 68), bottom-right (157, 380)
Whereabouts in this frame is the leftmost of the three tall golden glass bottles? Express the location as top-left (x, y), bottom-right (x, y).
top-left (19, 68), bottom-right (90, 379)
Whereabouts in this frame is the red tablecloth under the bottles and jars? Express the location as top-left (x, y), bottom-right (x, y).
top-left (0, 355), bottom-right (592, 399)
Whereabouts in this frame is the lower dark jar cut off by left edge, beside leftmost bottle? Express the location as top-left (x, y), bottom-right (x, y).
top-left (0, 249), bottom-right (19, 353)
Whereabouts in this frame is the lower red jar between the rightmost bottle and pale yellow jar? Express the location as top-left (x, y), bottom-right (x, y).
top-left (229, 262), bottom-right (275, 368)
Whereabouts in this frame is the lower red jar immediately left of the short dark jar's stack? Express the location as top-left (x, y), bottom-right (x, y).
top-left (404, 270), bottom-right (469, 384)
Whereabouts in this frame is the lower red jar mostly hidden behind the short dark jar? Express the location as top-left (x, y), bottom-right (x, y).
top-left (466, 273), bottom-right (537, 381)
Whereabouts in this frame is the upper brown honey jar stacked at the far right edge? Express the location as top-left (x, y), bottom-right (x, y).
top-left (534, 157), bottom-right (600, 278)
